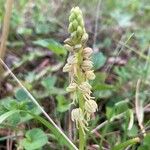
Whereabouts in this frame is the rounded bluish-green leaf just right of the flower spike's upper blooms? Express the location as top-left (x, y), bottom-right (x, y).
top-left (92, 52), bottom-right (106, 70)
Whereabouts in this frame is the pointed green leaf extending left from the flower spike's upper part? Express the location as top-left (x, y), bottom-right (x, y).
top-left (33, 39), bottom-right (67, 55)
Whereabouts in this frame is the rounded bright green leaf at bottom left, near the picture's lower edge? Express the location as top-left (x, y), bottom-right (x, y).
top-left (22, 128), bottom-right (48, 150)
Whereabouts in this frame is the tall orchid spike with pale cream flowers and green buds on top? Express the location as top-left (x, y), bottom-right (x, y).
top-left (63, 7), bottom-right (97, 150)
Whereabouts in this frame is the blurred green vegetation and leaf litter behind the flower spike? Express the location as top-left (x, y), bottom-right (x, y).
top-left (0, 0), bottom-right (150, 150)
